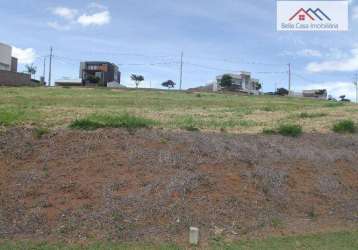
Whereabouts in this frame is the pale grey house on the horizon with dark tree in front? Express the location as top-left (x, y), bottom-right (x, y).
top-left (213, 71), bottom-right (261, 95)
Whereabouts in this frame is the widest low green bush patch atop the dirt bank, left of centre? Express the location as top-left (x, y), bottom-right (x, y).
top-left (70, 114), bottom-right (154, 130)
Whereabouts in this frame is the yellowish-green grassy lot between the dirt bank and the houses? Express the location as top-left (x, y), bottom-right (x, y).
top-left (0, 88), bottom-right (358, 133)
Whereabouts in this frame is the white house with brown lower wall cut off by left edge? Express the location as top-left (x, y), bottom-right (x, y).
top-left (0, 43), bottom-right (34, 86)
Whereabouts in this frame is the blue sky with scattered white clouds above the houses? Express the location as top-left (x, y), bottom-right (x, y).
top-left (0, 0), bottom-right (358, 99)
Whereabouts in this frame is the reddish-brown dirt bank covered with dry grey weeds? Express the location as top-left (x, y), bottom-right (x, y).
top-left (0, 128), bottom-right (358, 243)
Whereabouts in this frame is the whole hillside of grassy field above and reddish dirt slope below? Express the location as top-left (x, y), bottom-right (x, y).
top-left (0, 88), bottom-right (358, 249)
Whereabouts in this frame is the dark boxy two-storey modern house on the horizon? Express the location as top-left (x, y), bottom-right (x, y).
top-left (80, 61), bottom-right (121, 87)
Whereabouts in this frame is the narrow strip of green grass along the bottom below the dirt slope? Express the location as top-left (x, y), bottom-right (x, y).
top-left (0, 231), bottom-right (358, 250)
